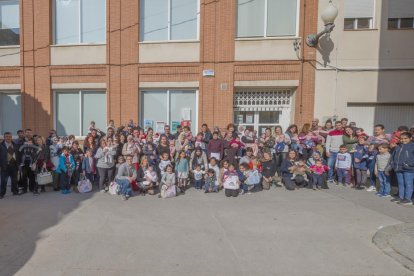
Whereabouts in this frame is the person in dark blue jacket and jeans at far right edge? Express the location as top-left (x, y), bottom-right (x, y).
top-left (391, 132), bottom-right (414, 205)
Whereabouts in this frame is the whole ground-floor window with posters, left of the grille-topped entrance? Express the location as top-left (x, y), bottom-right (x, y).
top-left (140, 90), bottom-right (198, 133)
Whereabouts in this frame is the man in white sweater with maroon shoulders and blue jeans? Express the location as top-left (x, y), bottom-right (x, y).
top-left (325, 121), bottom-right (344, 183)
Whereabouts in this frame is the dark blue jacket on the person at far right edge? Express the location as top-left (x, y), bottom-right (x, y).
top-left (391, 142), bottom-right (414, 172)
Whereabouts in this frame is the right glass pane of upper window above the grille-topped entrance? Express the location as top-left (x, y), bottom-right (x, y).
top-left (267, 0), bottom-right (297, 36)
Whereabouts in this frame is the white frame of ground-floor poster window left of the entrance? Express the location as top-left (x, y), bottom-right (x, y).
top-left (138, 87), bottom-right (200, 135)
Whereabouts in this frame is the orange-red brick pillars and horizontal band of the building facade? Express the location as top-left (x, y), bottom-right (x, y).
top-left (0, 0), bottom-right (318, 134)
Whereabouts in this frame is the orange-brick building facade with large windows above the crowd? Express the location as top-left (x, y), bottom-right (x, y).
top-left (0, 0), bottom-right (318, 136)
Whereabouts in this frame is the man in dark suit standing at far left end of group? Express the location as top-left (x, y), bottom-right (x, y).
top-left (0, 132), bottom-right (20, 199)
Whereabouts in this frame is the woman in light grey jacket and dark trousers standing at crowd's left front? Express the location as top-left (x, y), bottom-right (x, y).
top-left (95, 139), bottom-right (116, 191)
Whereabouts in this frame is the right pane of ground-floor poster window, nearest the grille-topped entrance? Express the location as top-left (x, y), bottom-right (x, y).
top-left (170, 91), bottom-right (197, 133)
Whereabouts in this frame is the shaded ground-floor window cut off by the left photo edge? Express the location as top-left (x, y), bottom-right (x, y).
top-left (0, 92), bottom-right (22, 135)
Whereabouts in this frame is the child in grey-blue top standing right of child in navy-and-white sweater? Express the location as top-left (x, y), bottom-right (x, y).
top-left (354, 136), bottom-right (368, 190)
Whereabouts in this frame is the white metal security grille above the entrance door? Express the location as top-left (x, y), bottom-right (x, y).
top-left (233, 89), bottom-right (292, 111)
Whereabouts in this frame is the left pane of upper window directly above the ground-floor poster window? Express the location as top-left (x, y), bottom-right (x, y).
top-left (140, 0), bottom-right (168, 41)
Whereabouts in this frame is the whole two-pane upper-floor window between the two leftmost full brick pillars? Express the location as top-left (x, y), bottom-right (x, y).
top-left (54, 0), bottom-right (106, 44)
